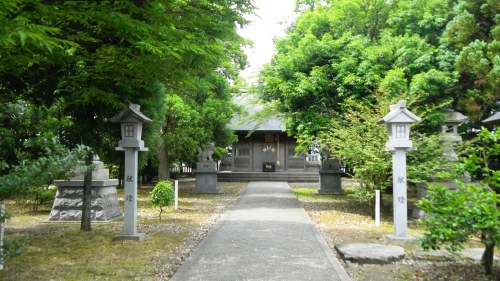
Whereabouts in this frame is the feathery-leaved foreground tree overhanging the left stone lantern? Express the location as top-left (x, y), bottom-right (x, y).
top-left (0, 0), bottom-right (253, 228)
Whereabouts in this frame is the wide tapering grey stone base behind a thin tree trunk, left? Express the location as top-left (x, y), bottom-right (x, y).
top-left (47, 155), bottom-right (122, 222)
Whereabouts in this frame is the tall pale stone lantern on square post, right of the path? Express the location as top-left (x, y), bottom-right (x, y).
top-left (377, 100), bottom-right (421, 240)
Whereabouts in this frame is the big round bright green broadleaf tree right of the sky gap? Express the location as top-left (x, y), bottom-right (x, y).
top-left (259, 1), bottom-right (458, 150)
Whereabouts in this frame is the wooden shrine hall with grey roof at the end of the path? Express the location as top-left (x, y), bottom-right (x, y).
top-left (219, 95), bottom-right (320, 182)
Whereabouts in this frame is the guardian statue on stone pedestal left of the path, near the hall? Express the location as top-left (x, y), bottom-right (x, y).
top-left (193, 143), bottom-right (222, 194)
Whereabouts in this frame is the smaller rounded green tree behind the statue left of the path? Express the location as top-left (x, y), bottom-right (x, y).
top-left (158, 76), bottom-right (239, 180)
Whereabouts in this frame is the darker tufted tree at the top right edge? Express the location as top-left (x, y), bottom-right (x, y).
top-left (442, 0), bottom-right (500, 121)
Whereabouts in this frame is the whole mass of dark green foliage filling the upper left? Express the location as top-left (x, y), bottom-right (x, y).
top-left (0, 0), bottom-right (253, 195)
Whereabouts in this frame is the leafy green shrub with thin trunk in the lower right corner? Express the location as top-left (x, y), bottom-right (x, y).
top-left (417, 183), bottom-right (500, 274)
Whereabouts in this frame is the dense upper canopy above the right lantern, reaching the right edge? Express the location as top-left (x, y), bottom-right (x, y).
top-left (259, 0), bottom-right (500, 138)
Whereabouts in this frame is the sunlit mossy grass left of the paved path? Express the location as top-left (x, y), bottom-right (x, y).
top-left (0, 180), bottom-right (246, 280)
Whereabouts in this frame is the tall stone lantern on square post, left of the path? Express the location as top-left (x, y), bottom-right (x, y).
top-left (110, 103), bottom-right (152, 241)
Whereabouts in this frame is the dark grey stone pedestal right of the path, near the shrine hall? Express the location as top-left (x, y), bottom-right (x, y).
top-left (316, 159), bottom-right (344, 195)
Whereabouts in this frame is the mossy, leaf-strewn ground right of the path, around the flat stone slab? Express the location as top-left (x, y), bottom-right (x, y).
top-left (290, 182), bottom-right (500, 281)
